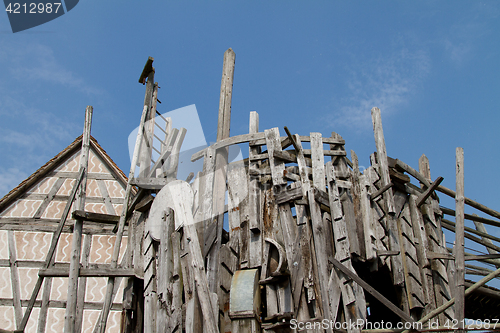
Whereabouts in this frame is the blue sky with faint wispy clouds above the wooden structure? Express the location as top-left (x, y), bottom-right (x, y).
top-left (0, 0), bottom-right (500, 246)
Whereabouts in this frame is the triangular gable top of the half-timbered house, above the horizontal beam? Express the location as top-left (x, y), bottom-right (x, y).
top-left (0, 136), bottom-right (127, 218)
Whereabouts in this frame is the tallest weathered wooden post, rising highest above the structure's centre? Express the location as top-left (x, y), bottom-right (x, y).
top-left (207, 49), bottom-right (236, 293)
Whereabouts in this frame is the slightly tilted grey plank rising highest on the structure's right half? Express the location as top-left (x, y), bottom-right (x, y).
top-left (371, 108), bottom-right (397, 214)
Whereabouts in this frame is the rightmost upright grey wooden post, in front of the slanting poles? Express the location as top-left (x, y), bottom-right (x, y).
top-left (454, 147), bottom-right (465, 332)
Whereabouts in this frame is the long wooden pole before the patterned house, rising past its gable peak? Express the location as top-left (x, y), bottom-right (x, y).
top-left (64, 106), bottom-right (93, 332)
